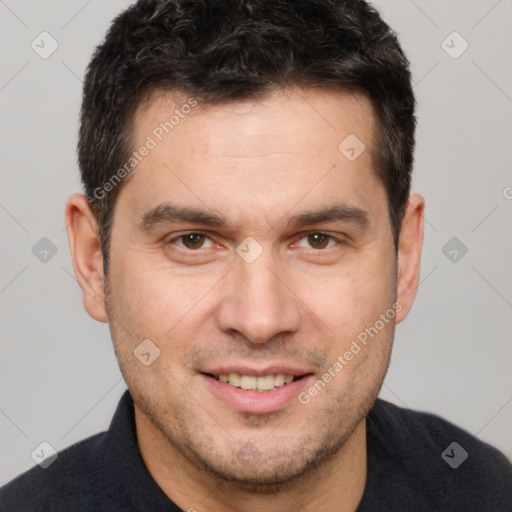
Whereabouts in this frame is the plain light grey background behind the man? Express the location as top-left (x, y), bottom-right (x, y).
top-left (0, 0), bottom-right (512, 484)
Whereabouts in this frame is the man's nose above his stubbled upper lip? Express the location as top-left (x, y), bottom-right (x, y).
top-left (217, 250), bottom-right (301, 344)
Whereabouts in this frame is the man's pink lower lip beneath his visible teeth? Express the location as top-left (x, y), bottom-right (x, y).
top-left (199, 373), bottom-right (313, 414)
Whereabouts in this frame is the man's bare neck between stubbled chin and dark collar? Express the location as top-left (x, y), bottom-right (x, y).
top-left (135, 407), bottom-right (367, 512)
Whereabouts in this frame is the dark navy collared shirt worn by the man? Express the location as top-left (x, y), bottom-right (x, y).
top-left (0, 391), bottom-right (512, 512)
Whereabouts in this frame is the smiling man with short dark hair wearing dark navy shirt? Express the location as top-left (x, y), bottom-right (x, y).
top-left (0, 0), bottom-right (512, 512)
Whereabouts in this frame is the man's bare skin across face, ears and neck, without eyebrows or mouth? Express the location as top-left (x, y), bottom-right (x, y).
top-left (66, 89), bottom-right (424, 512)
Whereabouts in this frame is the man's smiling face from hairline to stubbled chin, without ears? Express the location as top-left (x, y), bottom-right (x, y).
top-left (106, 90), bottom-right (400, 486)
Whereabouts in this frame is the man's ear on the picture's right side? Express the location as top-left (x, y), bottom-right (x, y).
top-left (396, 194), bottom-right (425, 323)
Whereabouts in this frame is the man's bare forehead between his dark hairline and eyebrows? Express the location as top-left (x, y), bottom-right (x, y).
top-left (117, 89), bottom-right (384, 227)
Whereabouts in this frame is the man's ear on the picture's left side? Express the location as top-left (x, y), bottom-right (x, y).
top-left (66, 194), bottom-right (107, 322)
